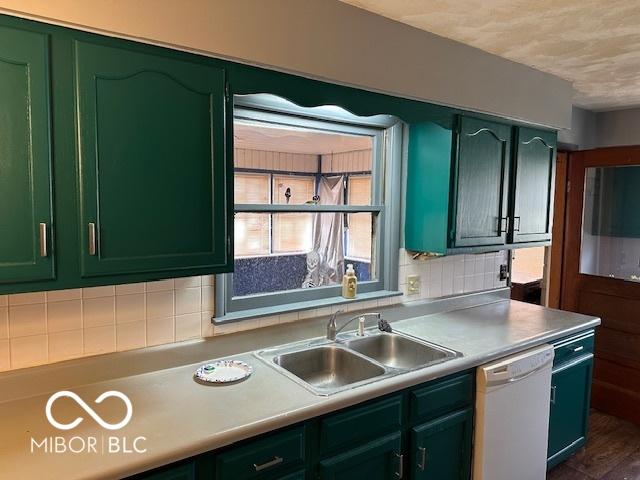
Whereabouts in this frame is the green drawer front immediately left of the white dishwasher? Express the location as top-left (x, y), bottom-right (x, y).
top-left (411, 373), bottom-right (473, 421)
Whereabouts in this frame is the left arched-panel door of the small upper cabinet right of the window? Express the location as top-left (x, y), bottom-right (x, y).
top-left (451, 117), bottom-right (511, 247)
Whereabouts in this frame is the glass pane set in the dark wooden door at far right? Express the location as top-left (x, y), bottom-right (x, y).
top-left (580, 166), bottom-right (640, 282)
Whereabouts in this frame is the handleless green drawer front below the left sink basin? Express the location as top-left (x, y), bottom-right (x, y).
top-left (320, 395), bottom-right (402, 453)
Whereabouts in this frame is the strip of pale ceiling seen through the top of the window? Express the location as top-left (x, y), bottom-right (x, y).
top-left (233, 121), bottom-right (372, 155)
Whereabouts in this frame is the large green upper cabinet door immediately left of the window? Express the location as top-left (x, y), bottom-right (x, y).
top-left (74, 40), bottom-right (231, 276)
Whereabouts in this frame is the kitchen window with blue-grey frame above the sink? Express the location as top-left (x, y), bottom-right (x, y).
top-left (216, 96), bottom-right (402, 321)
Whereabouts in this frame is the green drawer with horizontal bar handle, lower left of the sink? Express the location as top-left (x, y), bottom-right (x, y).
top-left (216, 426), bottom-right (305, 480)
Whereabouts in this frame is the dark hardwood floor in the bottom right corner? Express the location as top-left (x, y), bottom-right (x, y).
top-left (547, 410), bottom-right (640, 480)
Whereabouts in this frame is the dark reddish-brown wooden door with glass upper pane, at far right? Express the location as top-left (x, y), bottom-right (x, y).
top-left (561, 147), bottom-right (640, 423)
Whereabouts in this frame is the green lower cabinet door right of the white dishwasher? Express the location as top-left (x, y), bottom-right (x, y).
top-left (547, 355), bottom-right (593, 468)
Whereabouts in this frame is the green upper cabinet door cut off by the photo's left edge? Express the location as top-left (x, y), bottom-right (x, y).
top-left (0, 27), bottom-right (54, 284)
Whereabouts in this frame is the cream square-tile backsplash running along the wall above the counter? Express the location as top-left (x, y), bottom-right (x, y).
top-left (0, 249), bottom-right (507, 371)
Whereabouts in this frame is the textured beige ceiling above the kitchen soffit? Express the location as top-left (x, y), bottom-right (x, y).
top-left (341, 0), bottom-right (640, 110)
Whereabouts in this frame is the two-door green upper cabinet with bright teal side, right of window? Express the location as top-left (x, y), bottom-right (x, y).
top-left (405, 116), bottom-right (556, 255)
